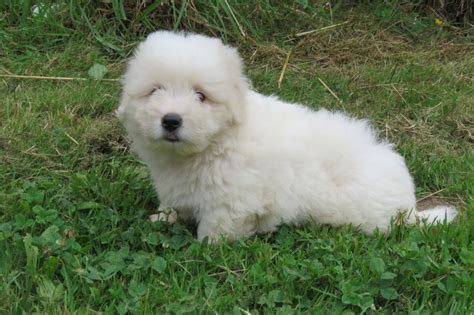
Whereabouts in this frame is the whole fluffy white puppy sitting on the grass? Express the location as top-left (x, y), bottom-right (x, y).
top-left (118, 31), bottom-right (456, 240)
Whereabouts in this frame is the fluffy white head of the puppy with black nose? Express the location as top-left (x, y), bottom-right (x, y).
top-left (117, 31), bottom-right (248, 154)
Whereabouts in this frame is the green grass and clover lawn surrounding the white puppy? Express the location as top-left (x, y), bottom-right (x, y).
top-left (0, 0), bottom-right (474, 314)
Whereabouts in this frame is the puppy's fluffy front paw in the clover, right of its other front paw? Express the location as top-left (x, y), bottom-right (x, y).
top-left (197, 210), bottom-right (256, 243)
